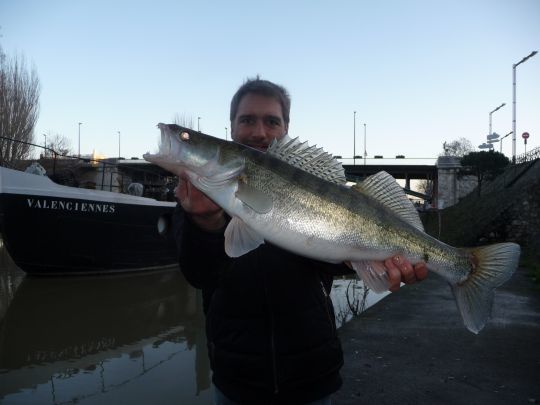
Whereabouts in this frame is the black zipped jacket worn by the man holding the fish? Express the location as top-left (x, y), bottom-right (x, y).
top-left (175, 209), bottom-right (349, 404)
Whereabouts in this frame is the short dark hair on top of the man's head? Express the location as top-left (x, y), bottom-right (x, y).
top-left (230, 76), bottom-right (291, 125)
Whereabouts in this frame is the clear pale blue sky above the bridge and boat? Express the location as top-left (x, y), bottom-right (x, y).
top-left (0, 0), bottom-right (540, 163)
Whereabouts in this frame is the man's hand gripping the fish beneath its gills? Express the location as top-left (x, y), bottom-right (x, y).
top-left (175, 175), bottom-right (225, 232)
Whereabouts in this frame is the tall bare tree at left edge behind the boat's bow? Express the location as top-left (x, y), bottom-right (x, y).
top-left (0, 47), bottom-right (40, 167)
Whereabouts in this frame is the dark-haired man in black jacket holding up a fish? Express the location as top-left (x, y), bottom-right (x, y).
top-left (175, 78), bottom-right (427, 404)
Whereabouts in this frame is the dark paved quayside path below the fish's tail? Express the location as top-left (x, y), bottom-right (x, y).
top-left (334, 269), bottom-right (540, 405)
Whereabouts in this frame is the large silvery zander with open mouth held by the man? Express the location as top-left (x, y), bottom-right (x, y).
top-left (144, 124), bottom-right (520, 333)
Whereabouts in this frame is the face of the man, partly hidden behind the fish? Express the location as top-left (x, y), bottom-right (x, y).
top-left (231, 93), bottom-right (288, 151)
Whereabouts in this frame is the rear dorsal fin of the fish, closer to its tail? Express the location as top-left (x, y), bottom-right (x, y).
top-left (351, 171), bottom-right (424, 232)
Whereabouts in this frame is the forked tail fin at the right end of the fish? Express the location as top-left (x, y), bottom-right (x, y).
top-left (452, 243), bottom-right (520, 333)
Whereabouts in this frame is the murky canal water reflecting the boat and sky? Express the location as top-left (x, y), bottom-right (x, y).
top-left (0, 239), bottom-right (388, 405)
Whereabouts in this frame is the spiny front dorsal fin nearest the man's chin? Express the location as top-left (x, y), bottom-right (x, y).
top-left (266, 136), bottom-right (347, 184)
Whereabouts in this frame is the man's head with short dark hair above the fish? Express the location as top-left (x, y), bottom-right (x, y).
top-left (230, 77), bottom-right (291, 150)
